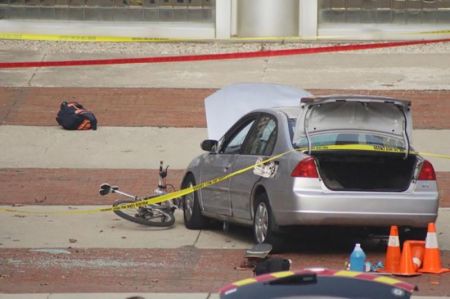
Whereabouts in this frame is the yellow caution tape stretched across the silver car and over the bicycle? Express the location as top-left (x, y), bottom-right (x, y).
top-left (0, 144), bottom-right (450, 215)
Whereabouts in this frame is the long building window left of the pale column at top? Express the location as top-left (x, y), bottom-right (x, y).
top-left (0, 0), bottom-right (215, 23)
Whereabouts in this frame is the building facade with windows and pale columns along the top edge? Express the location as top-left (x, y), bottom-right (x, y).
top-left (0, 0), bottom-right (450, 39)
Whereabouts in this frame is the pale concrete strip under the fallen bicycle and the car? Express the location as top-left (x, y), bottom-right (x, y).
top-left (0, 206), bottom-right (450, 250)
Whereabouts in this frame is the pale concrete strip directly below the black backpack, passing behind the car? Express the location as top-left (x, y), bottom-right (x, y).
top-left (0, 125), bottom-right (450, 171)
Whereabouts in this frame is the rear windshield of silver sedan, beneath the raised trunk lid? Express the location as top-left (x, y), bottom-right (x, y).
top-left (293, 132), bottom-right (405, 149)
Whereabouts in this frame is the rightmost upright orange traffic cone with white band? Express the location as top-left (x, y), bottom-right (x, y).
top-left (419, 223), bottom-right (450, 274)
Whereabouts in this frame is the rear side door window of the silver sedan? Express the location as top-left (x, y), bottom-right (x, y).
top-left (242, 115), bottom-right (277, 156)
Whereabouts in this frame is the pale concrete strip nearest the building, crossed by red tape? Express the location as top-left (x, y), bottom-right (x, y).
top-left (0, 41), bottom-right (450, 90)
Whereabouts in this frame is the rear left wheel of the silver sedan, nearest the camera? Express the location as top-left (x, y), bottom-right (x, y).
top-left (253, 193), bottom-right (282, 252)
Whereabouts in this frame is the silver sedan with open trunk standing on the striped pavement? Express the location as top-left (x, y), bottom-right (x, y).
top-left (182, 96), bottom-right (438, 248)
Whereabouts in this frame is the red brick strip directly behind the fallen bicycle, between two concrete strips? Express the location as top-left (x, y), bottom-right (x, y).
top-left (0, 168), bottom-right (450, 207)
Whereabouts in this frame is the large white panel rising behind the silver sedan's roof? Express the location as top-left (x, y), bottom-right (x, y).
top-left (205, 83), bottom-right (311, 140)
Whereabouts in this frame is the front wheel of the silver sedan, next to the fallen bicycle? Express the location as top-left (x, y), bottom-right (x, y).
top-left (182, 174), bottom-right (208, 229)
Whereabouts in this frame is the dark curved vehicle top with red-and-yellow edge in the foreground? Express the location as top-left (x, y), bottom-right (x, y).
top-left (219, 269), bottom-right (417, 299)
